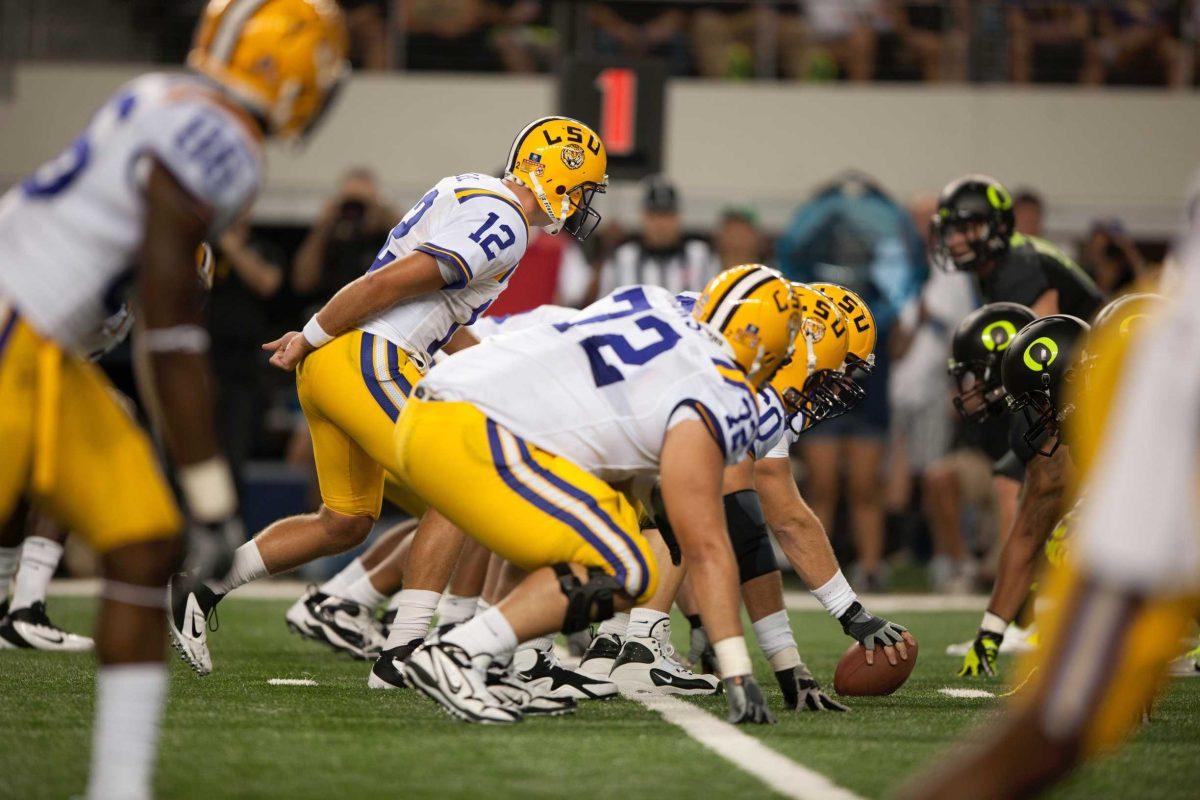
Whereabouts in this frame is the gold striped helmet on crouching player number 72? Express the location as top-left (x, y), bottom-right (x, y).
top-left (691, 264), bottom-right (800, 390)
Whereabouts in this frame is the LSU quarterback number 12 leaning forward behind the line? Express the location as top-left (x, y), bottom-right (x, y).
top-left (172, 116), bottom-right (608, 675)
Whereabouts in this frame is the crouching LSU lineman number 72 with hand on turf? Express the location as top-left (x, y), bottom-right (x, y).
top-left (396, 265), bottom-right (800, 723)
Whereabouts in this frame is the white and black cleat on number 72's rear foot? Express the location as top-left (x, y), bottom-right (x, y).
top-left (404, 643), bottom-right (521, 724)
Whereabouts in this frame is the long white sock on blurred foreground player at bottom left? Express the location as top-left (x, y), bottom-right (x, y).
top-left (88, 662), bottom-right (167, 800)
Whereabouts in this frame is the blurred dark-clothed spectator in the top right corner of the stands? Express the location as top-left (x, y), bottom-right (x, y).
top-left (1084, 0), bottom-right (1192, 89)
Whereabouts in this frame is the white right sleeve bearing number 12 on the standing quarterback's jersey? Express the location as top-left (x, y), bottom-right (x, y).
top-left (416, 196), bottom-right (529, 289)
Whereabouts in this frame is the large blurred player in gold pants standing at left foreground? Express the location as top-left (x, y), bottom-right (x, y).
top-left (0, 0), bottom-right (347, 798)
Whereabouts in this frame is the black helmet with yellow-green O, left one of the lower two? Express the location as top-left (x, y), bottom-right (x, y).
top-left (949, 302), bottom-right (1034, 422)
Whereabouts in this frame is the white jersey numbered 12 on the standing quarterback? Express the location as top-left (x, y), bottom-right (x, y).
top-left (359, 173), bottom-right (529, 369)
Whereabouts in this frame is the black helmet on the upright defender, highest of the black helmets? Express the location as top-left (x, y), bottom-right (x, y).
top-left (930, 175), bottom-right (1014, 272)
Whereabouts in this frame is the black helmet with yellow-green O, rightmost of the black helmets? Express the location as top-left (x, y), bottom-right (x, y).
top-left (1000, 314), bottom-right (1090, 457)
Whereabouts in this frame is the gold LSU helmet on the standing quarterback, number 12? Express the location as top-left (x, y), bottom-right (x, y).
top-left (504, 116), bottom-right (608, 241)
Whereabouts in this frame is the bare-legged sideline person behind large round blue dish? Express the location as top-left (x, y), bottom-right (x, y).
top-left (776, 173), bottom-right (925, 590)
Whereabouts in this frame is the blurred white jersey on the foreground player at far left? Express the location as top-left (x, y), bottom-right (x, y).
top-left (0, 74), bottom-right (263, 355)
